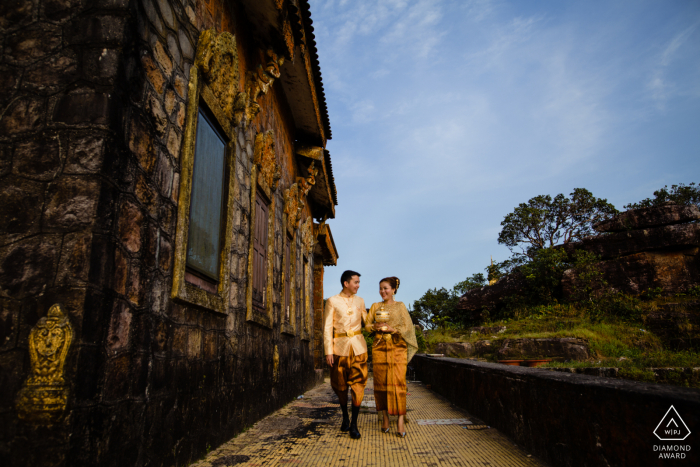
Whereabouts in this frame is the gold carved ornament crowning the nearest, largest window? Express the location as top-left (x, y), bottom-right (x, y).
top-left (195, 29), bottom-right (244, 124)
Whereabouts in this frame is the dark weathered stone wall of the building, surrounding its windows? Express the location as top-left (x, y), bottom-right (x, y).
top-left (0, 0), bottom-right (328, 466)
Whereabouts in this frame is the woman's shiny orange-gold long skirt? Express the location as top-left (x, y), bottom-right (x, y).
top-left (372, 334), bottom-right (408, 415)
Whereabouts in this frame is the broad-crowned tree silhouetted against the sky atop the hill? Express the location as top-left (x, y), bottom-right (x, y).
top-left (498, 188), bottom-right (617, 258)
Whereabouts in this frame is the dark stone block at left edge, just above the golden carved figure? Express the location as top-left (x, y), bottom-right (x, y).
top-left (0, 235), bottom-right (61, 299)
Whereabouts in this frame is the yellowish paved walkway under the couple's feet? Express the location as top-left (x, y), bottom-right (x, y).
top-left (193, 379), bottom-right (543, 467)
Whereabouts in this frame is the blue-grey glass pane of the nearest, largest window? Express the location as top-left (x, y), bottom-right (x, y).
top-left (187, 110), bottom-right (226, 280)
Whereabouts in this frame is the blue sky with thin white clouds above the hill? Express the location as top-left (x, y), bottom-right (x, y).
top-left (311, 0), bottom-right (700, 305)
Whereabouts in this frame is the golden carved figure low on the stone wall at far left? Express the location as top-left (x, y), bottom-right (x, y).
top-left (17, 304), bottom-right (73, 422)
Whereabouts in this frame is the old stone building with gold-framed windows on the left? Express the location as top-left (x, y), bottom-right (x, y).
top-left (0, 0), bottom-right (338, 466)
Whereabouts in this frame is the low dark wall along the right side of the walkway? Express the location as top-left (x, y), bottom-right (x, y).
top-left (411, 355), bottom-right (700, 466)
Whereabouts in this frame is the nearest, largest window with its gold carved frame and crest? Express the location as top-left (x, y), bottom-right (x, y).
top-left (171, 30), bottom-right (238, 313)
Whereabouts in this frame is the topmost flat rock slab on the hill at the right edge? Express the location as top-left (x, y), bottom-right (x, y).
top-left (593, 203), bottom-right (700, 232)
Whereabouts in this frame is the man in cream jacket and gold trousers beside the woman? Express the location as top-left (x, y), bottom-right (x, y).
top-left (323, 271), bottom-right (368, 439)
